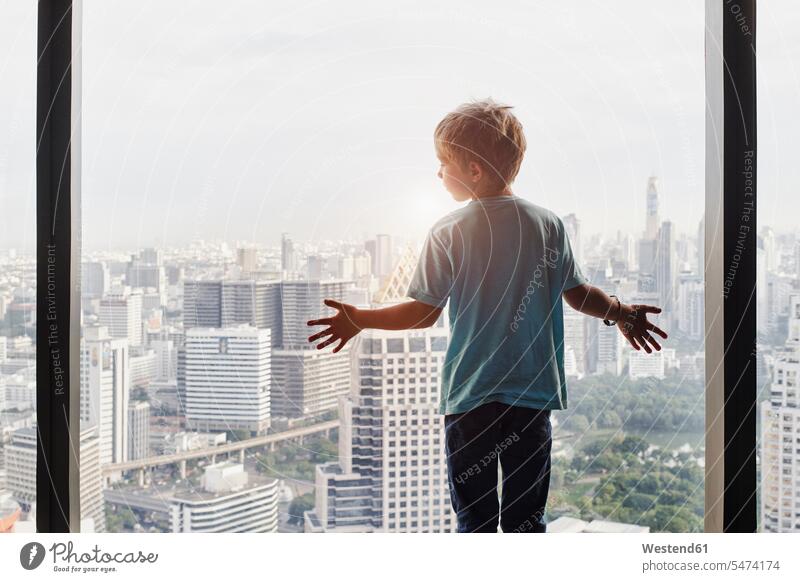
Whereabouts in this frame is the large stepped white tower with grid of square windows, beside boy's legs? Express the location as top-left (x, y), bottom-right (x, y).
top-left (305, 319), bottom-right (455, 532)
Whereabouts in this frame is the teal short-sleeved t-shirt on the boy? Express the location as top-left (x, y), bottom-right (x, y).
top-left (408, 195), bottom-right (587, 414)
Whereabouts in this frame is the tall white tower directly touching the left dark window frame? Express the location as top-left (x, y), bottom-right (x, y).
top-left (81, 326), bottom-right (131, 465)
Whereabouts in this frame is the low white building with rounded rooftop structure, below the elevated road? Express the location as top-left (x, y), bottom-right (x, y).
top-left (169, 462), bottom-right (278, 533)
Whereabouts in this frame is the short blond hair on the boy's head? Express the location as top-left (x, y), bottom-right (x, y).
top-left (433, 98), bottom-right (527, 186)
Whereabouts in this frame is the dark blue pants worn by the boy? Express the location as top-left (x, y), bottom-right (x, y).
top-left (444, 402), bottom-right (553, 533)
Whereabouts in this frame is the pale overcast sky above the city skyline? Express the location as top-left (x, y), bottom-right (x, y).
top-left (0, 0), bottom-right (800, 249)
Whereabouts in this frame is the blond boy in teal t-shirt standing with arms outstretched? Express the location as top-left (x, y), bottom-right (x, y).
top-left (308, 99), bottom-right (667, 532)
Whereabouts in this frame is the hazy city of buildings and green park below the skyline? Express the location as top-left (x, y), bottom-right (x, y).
top-left (0, 176), bottom-right (800, 533)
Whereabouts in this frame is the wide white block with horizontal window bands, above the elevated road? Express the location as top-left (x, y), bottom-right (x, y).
top-left (185, 325), bottom-right (271, 433)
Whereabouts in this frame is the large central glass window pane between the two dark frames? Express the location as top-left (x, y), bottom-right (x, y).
top-left (82, 0), bottom-right (704, 532)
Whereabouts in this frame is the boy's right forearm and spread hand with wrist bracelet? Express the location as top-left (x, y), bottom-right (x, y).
top-left (563, 283), bottom-right (667, 354)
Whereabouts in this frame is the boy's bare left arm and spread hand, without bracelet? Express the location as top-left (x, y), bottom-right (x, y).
top-left (306, 299), bottom-right (442, 353)
